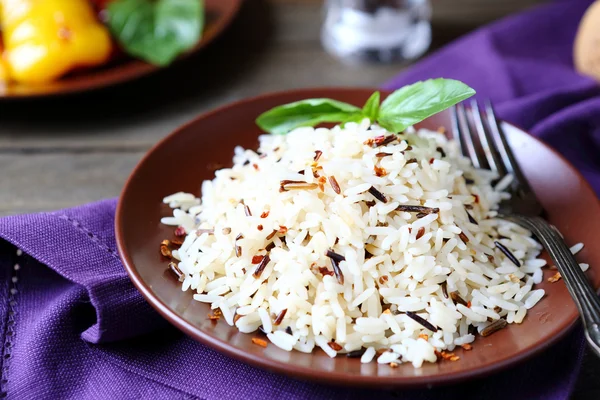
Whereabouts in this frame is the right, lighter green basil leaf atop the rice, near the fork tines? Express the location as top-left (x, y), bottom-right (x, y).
top-left (378, 78), bottom-right (475, 132)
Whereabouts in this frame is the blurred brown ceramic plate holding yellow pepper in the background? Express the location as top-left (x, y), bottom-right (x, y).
top-left (0, 0), bottom-right (242, 99)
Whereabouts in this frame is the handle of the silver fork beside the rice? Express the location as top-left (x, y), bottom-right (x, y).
top-left (504, 215), bottom-right (600, 357)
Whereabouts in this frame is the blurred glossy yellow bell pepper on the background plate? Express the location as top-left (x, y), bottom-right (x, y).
top-left (0, 0), bottom-right (112, 83)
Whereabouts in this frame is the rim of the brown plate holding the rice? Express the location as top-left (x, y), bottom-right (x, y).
top-left (115, 86), bottom-right (598, 388)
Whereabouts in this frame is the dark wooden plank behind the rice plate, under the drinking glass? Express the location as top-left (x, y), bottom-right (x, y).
top-left (0, 0), bottom-right (548, 152)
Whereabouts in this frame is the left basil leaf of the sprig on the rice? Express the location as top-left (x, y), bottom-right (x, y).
top-left (256, 99), bottom-right (361, 135)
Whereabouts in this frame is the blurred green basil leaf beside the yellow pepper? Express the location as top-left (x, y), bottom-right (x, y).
top-left (106, 0), bottom-right (204, 66)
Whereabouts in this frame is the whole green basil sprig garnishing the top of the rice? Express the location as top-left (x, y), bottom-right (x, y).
top-left (256, 78), bottom-right (475, 135)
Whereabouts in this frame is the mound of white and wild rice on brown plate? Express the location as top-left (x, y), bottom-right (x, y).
top-left (162, 120), bottom-right (546, 368)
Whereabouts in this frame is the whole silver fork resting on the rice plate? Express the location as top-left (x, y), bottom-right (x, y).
top-left (451, 100), bottom-right (600, 356)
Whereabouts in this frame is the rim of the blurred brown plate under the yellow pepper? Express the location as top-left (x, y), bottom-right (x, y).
top-left (0, 0), bottom-right (244, 101)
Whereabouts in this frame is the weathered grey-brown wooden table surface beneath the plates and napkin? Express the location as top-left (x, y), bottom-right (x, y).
top-left (0, 0), bottom-right (600, 399)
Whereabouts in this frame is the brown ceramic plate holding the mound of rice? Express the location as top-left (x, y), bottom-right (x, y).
top-left (116, 89), bottom-right (600, 387)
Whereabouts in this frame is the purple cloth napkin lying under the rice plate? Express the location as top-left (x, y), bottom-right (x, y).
top-left (0, 0), bottom-right (600, 400)
